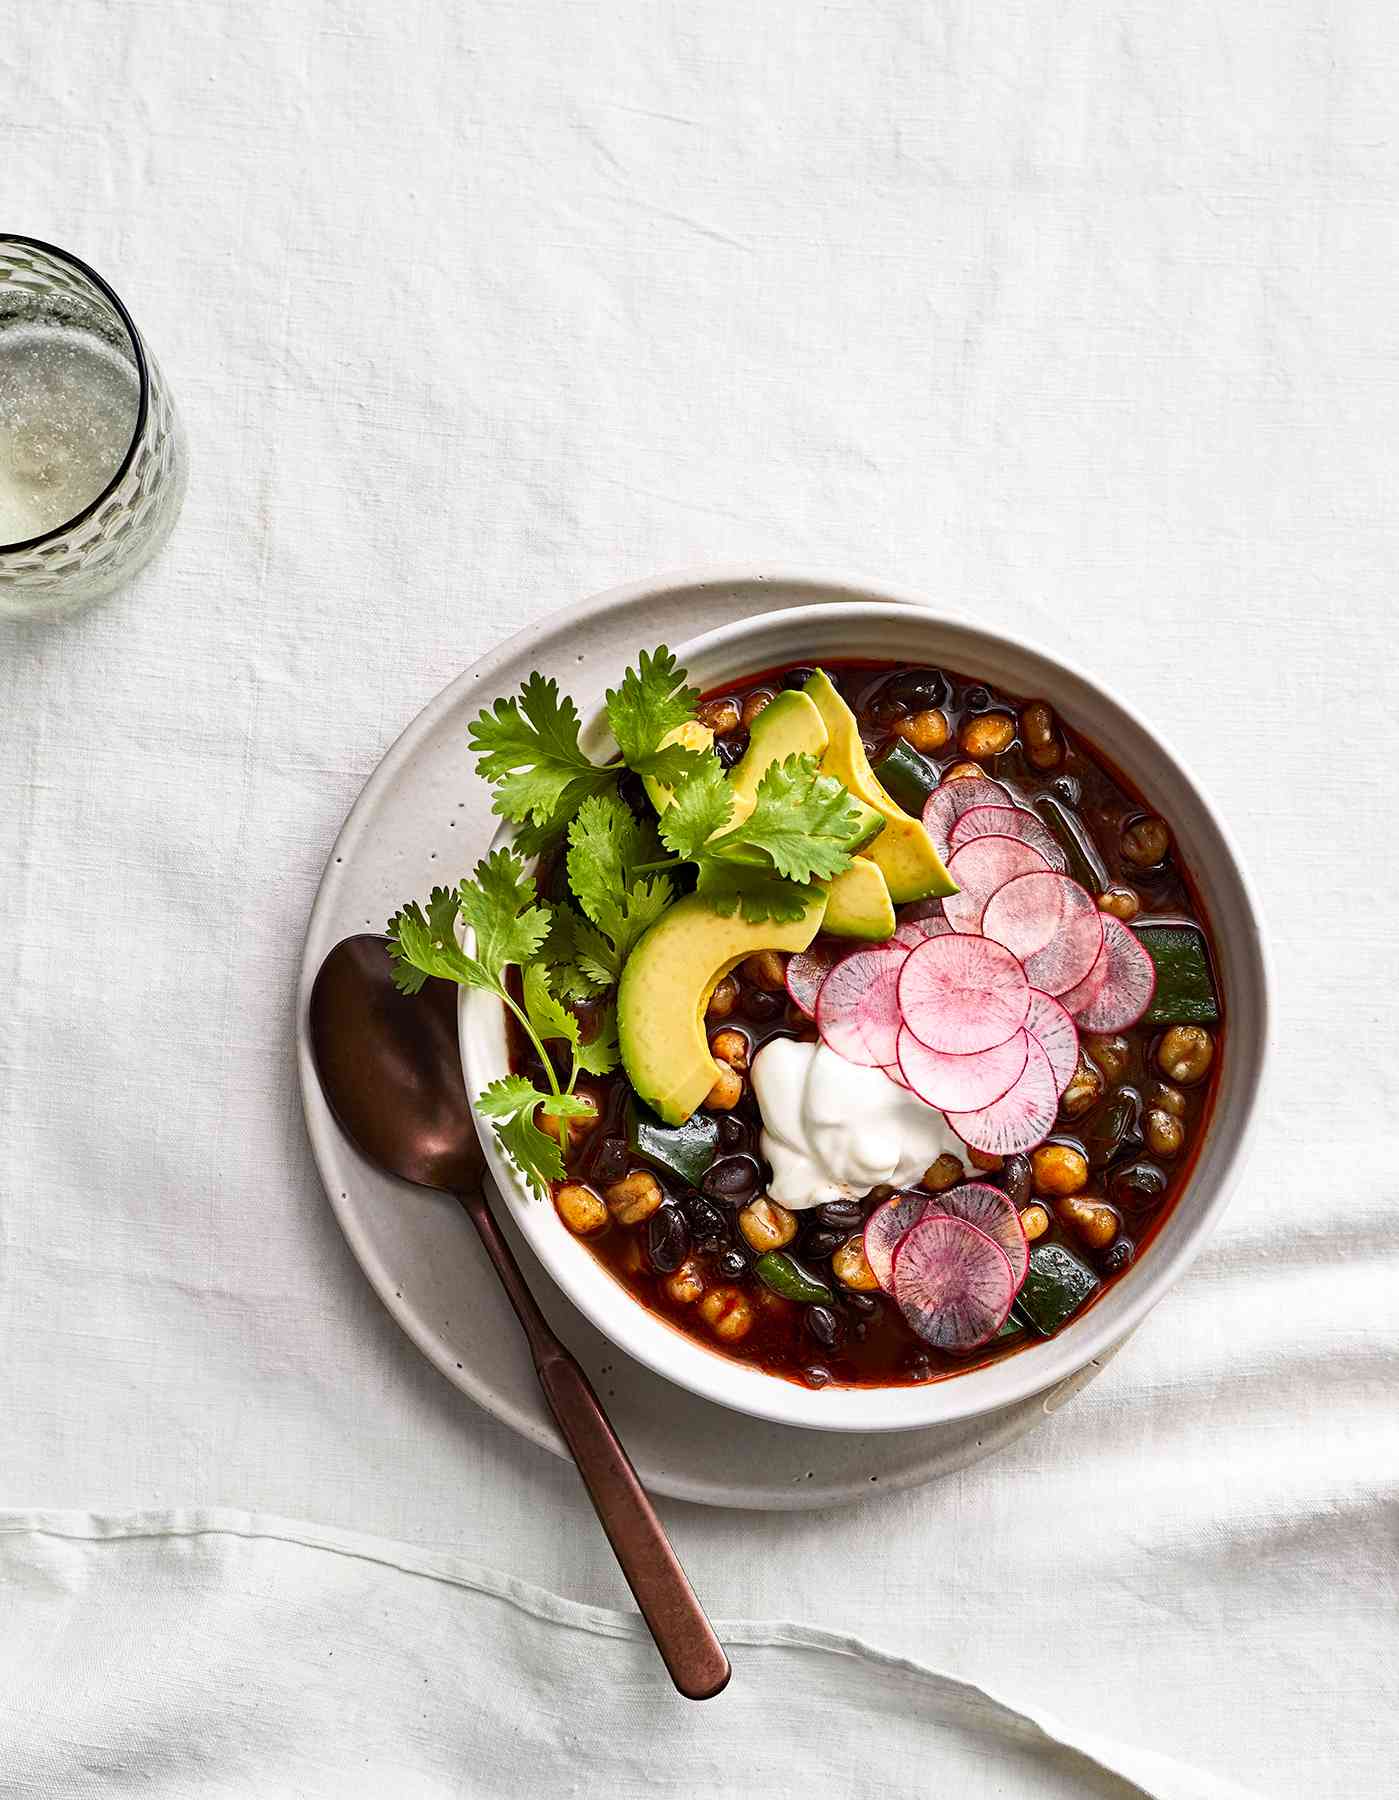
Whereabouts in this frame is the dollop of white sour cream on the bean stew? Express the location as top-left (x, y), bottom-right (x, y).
top-left (753, 1037), bottom-right (967, 1211)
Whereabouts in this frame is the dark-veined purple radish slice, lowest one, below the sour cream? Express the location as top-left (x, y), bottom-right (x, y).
top-left (896, 1213), bottom-right (1015, 1350)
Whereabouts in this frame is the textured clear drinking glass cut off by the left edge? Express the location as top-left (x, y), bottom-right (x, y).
top-left (0, 236), bottom-right (187, 619)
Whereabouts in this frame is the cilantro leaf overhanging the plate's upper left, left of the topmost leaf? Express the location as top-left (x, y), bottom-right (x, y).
top-left (470, 670), bottom-right (616, 826)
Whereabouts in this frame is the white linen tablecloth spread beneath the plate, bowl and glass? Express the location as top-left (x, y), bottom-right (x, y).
top-left (0, 0), bottom-right (1399, 1800)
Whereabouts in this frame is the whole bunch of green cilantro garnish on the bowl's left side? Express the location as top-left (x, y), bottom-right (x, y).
top-left (389, 644), bottom-right (866, 1192)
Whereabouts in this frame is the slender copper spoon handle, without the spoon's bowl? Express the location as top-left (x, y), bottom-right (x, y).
top-left (457, 1193), bottom-right (731, 1699)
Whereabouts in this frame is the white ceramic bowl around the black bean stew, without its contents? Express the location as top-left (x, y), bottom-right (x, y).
top-left (461, 583), bottom-right (1268, 1431)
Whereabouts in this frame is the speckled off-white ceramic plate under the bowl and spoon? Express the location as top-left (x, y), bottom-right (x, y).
top-left (297, 569), bottom-right (1107, 1508)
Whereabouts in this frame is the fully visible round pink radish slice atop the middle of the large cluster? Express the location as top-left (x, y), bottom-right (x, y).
top-left (896, 928), bottom-right (1030, 1062)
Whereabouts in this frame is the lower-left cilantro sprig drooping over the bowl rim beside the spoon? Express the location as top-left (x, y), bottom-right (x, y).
top-left (389, 850), bottom-right (618, 1193)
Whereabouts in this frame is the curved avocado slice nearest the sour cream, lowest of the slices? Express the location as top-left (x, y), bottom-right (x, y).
top-left (618, 886), bottom-right (826, 1125)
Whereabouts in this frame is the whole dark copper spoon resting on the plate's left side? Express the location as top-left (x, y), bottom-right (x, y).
top-left (310, 934), bottom-right (731, 1699)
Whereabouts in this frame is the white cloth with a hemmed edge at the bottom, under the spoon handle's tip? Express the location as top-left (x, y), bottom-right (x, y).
top-left (0, 1512), bottom-right (1248, 1800)
